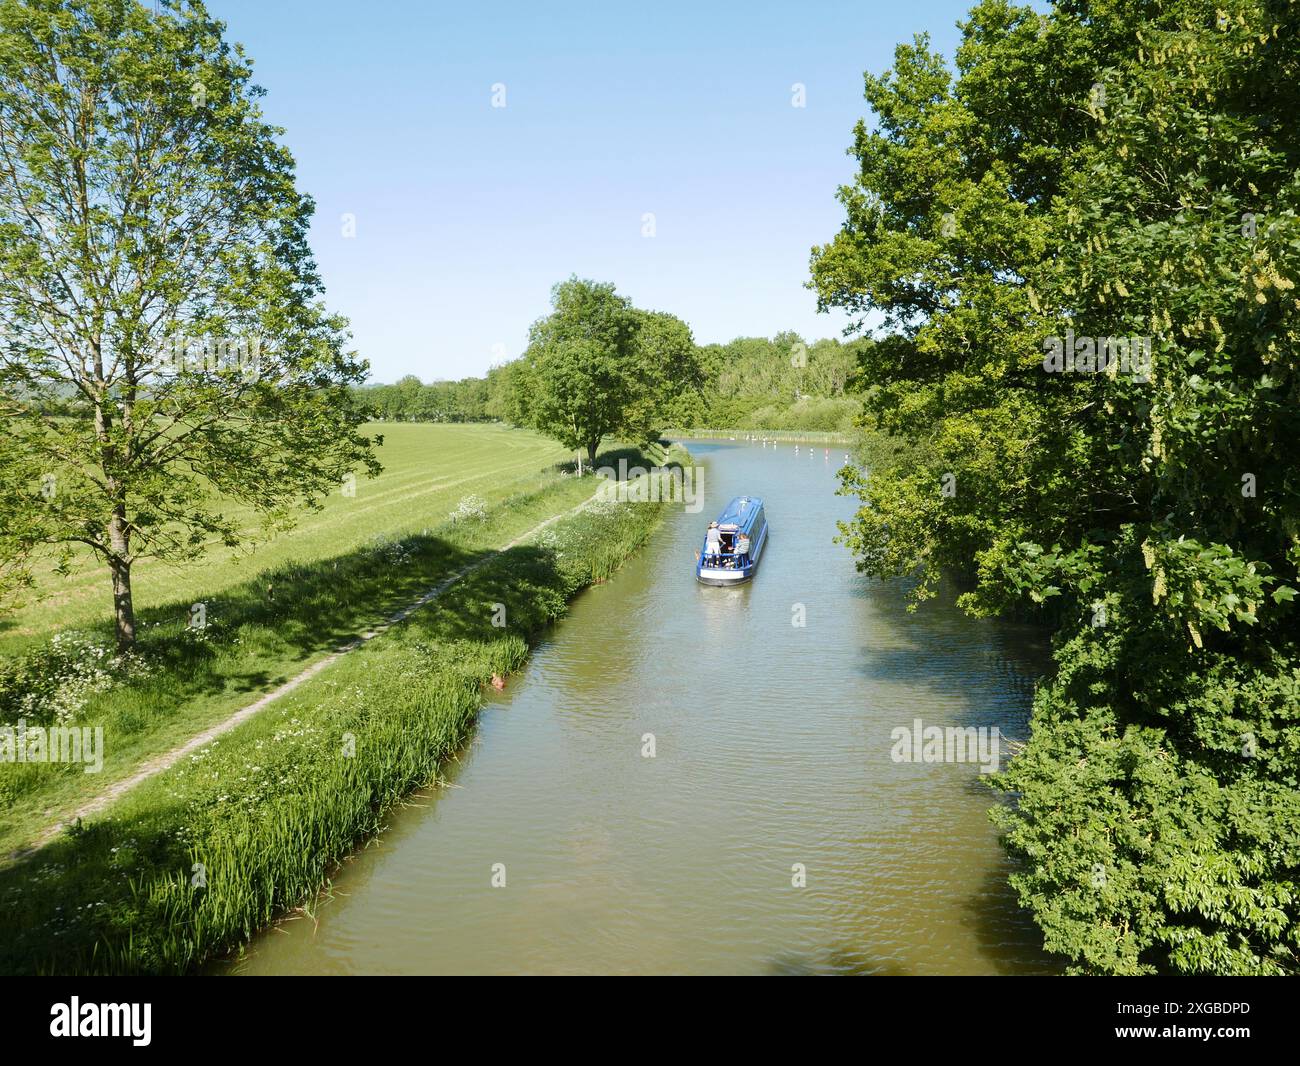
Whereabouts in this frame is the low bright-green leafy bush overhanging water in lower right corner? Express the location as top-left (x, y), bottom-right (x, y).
top-left (995, 621), bottom-right (1300, 974)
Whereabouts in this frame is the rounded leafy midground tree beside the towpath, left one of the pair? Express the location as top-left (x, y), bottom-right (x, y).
top-left (515, 277), bottom-right (650, 464)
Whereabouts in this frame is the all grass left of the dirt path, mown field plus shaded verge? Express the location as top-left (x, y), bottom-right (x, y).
top-left (0, 424), bottom-right (594, 863)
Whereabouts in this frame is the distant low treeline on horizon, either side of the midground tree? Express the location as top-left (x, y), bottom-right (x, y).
top-left (354, 333), bottom-right (870, 432)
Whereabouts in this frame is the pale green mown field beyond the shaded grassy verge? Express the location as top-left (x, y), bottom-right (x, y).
top-left (0, 423), bottom-right (571, 644)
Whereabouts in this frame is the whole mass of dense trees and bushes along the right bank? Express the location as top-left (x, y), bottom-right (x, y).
top-left (813, 0), bottom-right (1300, 974)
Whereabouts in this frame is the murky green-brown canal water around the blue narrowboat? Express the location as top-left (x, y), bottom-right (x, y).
top-left (221, 442), bottom-right (1053, 974)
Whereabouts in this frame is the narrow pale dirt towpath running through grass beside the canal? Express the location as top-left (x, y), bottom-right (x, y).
top-left (21, 491), bottom-right (599, 859)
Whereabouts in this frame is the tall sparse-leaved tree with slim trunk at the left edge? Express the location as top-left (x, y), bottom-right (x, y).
top-left (0, 0), bottom-right (378, 650)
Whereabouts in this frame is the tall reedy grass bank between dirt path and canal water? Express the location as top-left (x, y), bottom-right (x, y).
top-left (0, 454), bottom-right (660, 974)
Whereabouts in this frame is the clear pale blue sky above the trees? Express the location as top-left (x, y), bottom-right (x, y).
top-left (209, 0), bottom-right (969, 381)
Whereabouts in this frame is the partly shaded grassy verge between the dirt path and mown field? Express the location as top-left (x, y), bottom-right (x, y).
top-left (0, 471), bottom-right (593, 858)
